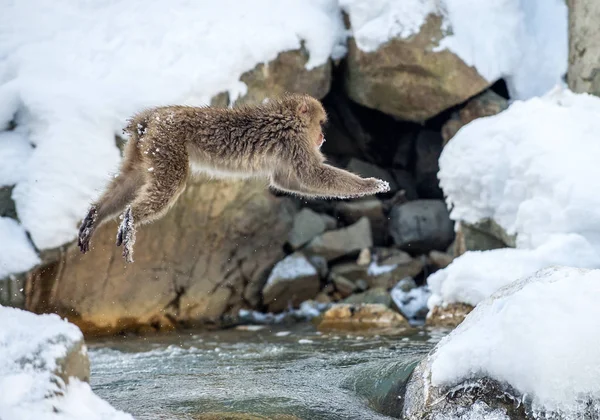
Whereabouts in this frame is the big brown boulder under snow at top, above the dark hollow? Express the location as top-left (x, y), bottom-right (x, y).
top-left (344, 15), bottom-right (490, 122)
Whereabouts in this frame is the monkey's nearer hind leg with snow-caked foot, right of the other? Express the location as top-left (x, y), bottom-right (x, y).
top-left (116, 153), bottom-right (188, 262)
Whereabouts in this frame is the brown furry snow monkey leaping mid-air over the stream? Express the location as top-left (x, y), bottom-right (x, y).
top-left (78, 94), bottom-right (389, 262)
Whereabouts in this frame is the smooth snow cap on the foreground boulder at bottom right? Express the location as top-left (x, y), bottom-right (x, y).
top-left (430, 267), bottom-right (600, 419)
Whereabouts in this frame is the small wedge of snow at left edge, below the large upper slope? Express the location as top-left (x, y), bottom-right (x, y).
top-left (0, 217), bottom-right (40, 281)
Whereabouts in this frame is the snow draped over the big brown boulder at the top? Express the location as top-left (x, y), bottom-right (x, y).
top-left (340, 0), bottom-right (568, 99)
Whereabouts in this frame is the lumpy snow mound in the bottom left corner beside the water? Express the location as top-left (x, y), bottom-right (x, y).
top-left (0, 306), bottom-right (133, 420)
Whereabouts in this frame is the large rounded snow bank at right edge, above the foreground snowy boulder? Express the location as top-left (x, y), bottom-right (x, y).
top-left (428, 88), bottom-right (600, 307)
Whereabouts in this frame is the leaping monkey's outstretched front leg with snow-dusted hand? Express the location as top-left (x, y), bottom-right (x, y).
top-left (296, 163), bottom-right (390, 198)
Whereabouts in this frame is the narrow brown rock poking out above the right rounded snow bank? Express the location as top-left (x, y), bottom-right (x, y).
top-left (442, 89), bottom-right (508, 146)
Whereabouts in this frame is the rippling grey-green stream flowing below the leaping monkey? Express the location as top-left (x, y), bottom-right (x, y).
top-left (89, 324), bottom-right (443, 420)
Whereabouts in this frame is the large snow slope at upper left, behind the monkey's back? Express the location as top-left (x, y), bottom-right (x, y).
top-left (0, 0), bottom-right (345, 253)
